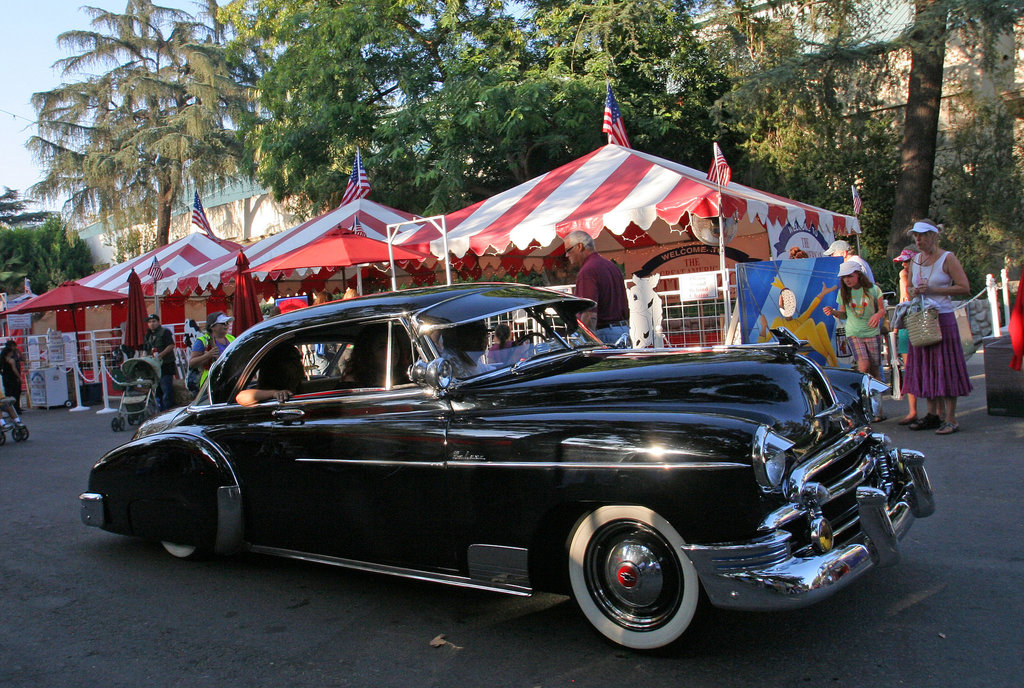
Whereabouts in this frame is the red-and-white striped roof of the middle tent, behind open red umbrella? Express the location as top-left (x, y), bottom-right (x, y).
top-left (159, 198), bottom-right (417, 294)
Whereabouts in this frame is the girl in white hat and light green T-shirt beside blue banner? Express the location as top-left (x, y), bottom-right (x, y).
top-left (821, 260), bottom-right (886, 413)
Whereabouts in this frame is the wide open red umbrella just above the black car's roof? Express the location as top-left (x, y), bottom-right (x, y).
top-left (250, 229), bottom-right (426, 272)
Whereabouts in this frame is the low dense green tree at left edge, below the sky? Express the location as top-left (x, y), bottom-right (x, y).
top-left (0, 215), bottom-right (92, 294)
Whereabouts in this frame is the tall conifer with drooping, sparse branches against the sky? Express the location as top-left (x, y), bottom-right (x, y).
top-left (29, 0), bottom-right (249, 245)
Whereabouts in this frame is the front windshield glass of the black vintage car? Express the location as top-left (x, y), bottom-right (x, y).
top-left (426, 305), bottom-right (603, 380)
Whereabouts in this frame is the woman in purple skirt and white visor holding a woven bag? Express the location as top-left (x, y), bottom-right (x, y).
top-left (903, 220), bottom-right (971, 435)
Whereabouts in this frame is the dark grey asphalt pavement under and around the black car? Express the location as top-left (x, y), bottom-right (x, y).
top-left (0, 353), bottom-right (1024, 688)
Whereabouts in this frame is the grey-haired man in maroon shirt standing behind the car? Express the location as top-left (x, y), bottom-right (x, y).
top-left (562, 230), bottom-right (630, 344)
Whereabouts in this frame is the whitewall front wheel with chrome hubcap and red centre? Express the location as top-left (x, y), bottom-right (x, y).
top-left (568, 506), bottom-right (700, 649)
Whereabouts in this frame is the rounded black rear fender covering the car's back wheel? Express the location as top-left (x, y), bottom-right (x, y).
top-left (89, 432), bottom-right (243, 554)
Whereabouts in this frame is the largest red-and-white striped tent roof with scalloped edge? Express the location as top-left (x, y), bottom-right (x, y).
top-left (395, 144), bottom-right (860, 269)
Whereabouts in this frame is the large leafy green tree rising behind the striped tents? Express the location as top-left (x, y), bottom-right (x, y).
top-left (224, 0), bottom-right (726, 212)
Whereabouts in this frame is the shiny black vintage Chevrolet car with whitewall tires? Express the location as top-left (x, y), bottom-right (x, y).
top-left (81, 284), bottom-right (934, 648)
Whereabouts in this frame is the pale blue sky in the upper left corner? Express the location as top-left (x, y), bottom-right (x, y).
top-left (0, 0), bottom-right (196, 204)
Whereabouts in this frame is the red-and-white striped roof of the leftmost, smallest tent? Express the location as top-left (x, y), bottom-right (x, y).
top-left (78, 231), bottom-right (242, 296)
